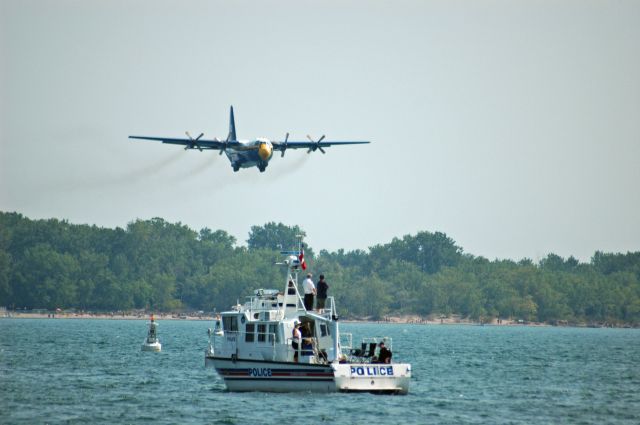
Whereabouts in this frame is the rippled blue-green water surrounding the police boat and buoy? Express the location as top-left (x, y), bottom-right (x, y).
top-left (0, 319), bottom-right (640, 425)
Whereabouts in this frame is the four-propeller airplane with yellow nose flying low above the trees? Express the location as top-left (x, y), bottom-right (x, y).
top-left (129, 106), bottom-right (370, 172)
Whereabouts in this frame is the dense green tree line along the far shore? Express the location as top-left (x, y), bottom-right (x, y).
top-left (0, 212), bottom-right (640, 325)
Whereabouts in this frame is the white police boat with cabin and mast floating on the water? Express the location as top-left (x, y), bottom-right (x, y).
top-left (205, 251), bottom-right (411, 394)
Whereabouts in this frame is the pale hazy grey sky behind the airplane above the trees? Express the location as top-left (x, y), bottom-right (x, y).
top-left (0, 0), bottom-right (640, 261)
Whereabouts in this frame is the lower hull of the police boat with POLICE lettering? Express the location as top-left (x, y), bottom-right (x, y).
top-left (205, 355), bottom-right (411, 394)
